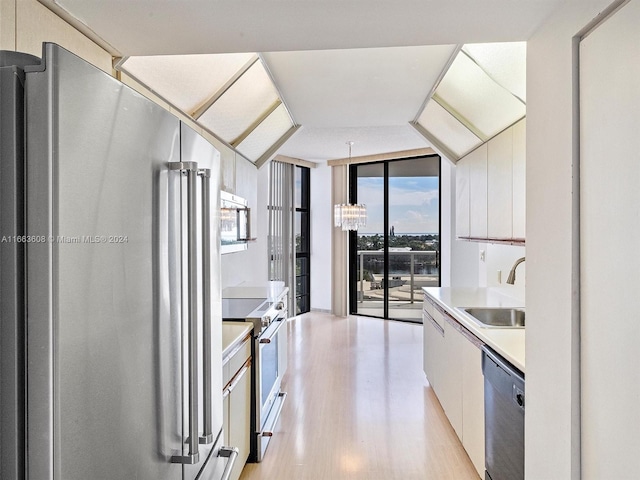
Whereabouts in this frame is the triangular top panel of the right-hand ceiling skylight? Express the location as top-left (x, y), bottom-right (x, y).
top-left (462, 42), bottom-right (527, 102)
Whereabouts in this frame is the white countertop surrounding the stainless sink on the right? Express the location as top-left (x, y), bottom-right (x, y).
top-left (423, 287), bottom-right (525, 373)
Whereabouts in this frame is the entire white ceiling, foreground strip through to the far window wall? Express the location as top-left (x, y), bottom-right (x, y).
top-left (45, 0), bottom-right (568, 161)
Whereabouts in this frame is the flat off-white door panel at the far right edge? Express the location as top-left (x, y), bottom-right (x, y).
top-left (579, 1), bottom-right (640, 480)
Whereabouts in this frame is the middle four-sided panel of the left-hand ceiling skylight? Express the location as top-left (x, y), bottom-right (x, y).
top-left (198, 62), bottom-right (280, 144)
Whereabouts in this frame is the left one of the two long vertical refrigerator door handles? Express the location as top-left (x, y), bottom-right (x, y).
top-left (169, 162), bottom-right (200, 465)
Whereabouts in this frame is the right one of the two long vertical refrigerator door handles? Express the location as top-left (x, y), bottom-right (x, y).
top-left (198, 168), bottom-right (215, 445)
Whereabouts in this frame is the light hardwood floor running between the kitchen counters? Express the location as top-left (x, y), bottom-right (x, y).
top-left (241, 313), bottom-right (479, 480)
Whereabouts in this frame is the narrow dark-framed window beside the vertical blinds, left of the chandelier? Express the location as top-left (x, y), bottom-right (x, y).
top-left (294, 166), bottom-right (311, 315)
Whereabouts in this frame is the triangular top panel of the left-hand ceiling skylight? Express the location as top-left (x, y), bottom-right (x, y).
top-left (119, 53), bottom-right (255, 114)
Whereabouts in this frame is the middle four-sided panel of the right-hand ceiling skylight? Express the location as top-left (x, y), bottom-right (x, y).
top-left (433, 52), bottom-right (526, 140)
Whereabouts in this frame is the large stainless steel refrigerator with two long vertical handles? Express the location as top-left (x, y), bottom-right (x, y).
top-left (0, 44), bottom-right (236, 480)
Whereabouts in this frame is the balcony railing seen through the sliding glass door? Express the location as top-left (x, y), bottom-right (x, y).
top-left (357, 250), bottom-right (440, 303)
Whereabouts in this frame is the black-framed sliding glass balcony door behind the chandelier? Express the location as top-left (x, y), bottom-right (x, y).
top-left (349, 155), bottom-right (440, 322)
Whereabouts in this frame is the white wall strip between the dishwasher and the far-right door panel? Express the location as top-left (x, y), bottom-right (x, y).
top-left (525, 0), bottom-right (609, 480)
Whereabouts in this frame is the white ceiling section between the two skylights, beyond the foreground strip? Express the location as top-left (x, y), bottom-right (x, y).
top-left (262, 45), bottom-right (455, 128)
